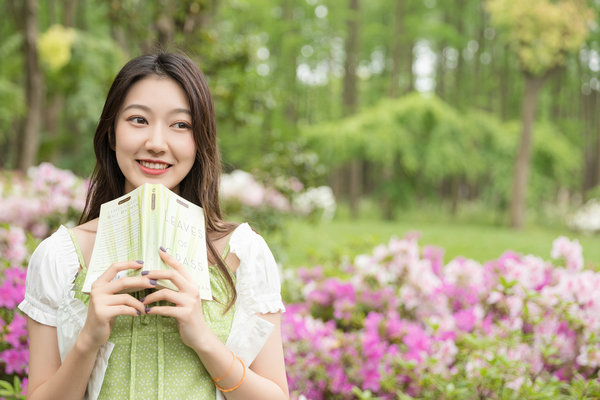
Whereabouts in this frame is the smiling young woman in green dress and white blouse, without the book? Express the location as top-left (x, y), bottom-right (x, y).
top-left (19, 53), bottom-right (289, 400)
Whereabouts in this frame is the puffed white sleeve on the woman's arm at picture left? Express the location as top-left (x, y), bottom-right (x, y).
top-left (19, 226), bottom-right (79, 326)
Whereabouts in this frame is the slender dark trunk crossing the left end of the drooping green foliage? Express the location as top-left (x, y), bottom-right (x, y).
top-left (342, 0), bottom-right (362, 218)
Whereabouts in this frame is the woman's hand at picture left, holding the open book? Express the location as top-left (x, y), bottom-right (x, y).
top-left (79, 261), bottom-right (156, 351)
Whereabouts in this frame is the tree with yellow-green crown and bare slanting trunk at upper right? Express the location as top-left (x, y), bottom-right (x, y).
top-left (487, 0), bottom-right (593, 228)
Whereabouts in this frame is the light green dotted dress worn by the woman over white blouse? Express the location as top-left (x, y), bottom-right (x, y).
top-left (69, 231), bottom-right (235, 400)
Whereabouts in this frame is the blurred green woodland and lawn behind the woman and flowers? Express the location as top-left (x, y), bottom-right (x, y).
top-left (0, 0), bottom-right (600, 266)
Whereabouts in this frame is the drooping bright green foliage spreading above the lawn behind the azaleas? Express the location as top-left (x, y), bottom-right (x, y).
top-left (303, 94), bottom-right (581, 216)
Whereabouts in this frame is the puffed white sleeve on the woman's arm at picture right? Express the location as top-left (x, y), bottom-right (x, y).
top-left (229, 223), bottom-right (285, 314)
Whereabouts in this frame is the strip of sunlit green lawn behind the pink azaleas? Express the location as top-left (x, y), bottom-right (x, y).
top-left (267, 216), bottom-right (600, 267)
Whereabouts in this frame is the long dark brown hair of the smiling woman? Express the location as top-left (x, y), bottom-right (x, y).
top-left (79, 53), bottom-right (237, 310)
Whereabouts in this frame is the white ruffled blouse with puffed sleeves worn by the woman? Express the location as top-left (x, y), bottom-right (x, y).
top-left (19, 223), bottom-right (285, 400)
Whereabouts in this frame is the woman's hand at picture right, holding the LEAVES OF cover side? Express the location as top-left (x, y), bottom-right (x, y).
top-left (143, 249), bottom-right (211, 349)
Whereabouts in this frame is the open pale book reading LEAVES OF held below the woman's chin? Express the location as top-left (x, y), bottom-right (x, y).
top-left (83, 183), bottom-right (212, 300)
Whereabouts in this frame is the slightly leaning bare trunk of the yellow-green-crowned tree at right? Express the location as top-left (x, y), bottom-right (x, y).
top-left (510, 74), bottom-right (548, 229)
